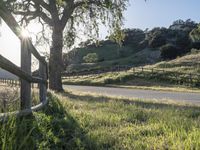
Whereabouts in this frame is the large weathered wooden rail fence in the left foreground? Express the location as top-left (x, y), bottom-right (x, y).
top-left (0, 3), bottom-right (48, 119)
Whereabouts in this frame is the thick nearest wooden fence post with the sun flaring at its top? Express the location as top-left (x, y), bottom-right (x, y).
top-left (20, 39), bottom-right (31, 110)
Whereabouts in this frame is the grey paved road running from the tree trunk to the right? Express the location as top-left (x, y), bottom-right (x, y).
top-left (64, 85), bottom-right (200, 104)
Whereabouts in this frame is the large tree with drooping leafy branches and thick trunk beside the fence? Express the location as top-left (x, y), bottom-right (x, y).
top-left (0, 0), bottom-right (128, 91)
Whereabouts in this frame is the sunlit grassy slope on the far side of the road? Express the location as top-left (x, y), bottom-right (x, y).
top-left (63, 53), bottom-right (200, 91)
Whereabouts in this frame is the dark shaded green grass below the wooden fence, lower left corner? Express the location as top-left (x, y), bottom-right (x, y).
top-left (0, 94), bottom-right (97, 150)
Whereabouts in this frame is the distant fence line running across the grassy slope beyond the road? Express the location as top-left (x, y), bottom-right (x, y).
top-left (63, 65), bottom-right (200, 87)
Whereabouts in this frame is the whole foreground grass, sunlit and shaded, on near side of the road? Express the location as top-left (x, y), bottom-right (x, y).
top-left (0, 92), bottom-right (200, 150)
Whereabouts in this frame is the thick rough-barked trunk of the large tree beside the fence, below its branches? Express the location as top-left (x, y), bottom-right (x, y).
top-left (49, 27), bottom-right (63, 92)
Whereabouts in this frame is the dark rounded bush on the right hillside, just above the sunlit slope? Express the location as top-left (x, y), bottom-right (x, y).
top-left (160, 44), bottom-right (181, 60)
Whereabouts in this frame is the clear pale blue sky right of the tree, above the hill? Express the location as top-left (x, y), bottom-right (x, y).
top-left (125, 0), bottom-right (200, 29)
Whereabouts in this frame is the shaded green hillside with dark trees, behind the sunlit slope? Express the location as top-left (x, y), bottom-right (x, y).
top-left (63, 19), bottom-right (200, 72)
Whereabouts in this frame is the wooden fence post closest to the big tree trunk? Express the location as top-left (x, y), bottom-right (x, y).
top-left (39, 57), bottom-right (47, 102)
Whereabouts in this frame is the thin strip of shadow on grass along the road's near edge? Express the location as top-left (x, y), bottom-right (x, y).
top-left (62, 91), bottom-right (199, 110)
